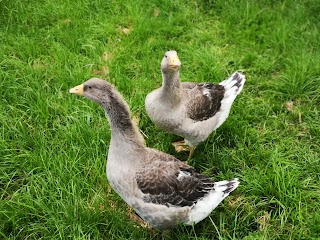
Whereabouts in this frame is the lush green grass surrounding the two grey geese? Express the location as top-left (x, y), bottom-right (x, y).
top-left (0, 0), bottom-right (320, 240)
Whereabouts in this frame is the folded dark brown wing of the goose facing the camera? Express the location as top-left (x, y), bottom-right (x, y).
top-left (184, 83), bottom-right (225, 121)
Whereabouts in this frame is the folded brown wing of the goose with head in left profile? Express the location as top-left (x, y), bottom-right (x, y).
top-left (136, 160), bottom-right (214, 206)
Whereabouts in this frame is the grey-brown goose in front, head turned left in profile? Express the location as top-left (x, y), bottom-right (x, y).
top-left (70, 78), bottom-right (239, 229)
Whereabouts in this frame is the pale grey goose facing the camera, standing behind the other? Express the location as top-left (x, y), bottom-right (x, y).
top-left (145, 50), bottom-right (246, 158)
